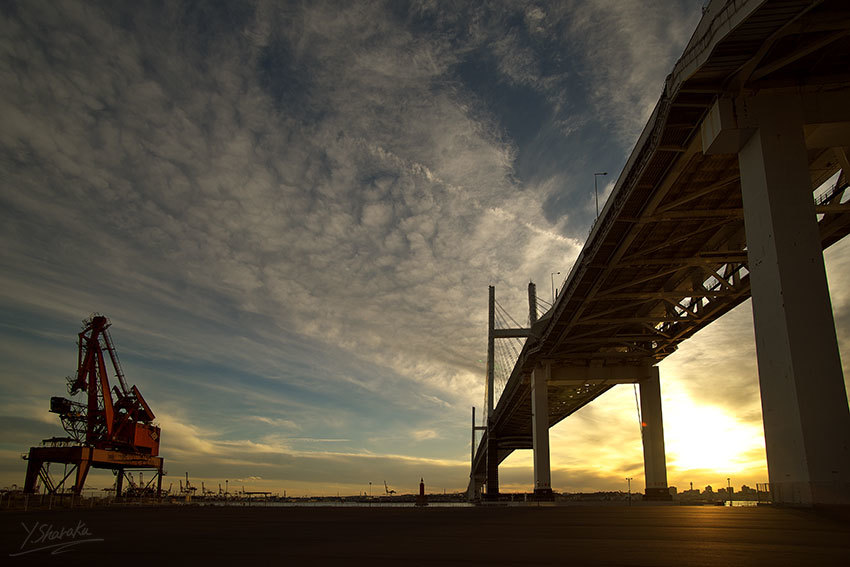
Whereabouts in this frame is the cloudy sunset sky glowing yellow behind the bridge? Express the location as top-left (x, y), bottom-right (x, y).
top-left (0, 0), bottom-right (850, 495)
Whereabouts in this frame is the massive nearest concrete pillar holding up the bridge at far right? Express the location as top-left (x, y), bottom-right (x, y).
top-left (738, 95), bottom-right (850, 505)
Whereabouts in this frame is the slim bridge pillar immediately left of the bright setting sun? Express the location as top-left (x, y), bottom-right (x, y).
top-left (640, 366), bottom-right (671, 500)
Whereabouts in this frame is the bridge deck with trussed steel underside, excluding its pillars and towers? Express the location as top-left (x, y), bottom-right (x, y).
top-left (474, 1), bottom-right (850, 478)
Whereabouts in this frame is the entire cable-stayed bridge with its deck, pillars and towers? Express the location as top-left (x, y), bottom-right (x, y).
top-left (469, 0), bottom-right (850, 505)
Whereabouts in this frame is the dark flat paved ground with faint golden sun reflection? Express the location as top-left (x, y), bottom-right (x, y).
top-left (0, 506), bottom-right (850, 566)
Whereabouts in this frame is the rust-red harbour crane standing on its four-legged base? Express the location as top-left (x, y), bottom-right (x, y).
top-left (24, 315), bottom-right (163, 496)
